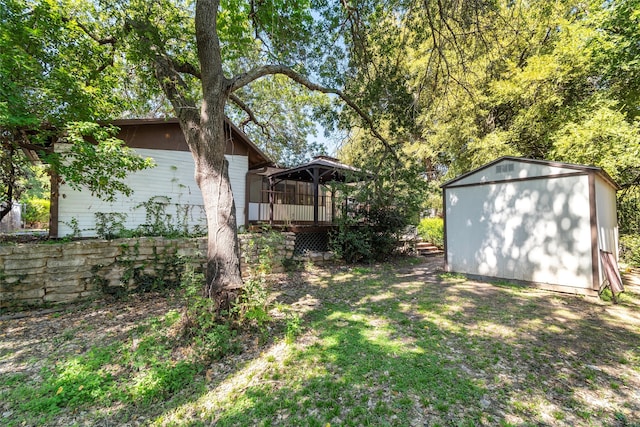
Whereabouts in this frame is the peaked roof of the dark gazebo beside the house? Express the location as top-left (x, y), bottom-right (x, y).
top-left (269, 156), bottom-right (362, 184)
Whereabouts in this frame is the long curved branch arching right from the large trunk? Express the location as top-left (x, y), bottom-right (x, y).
top-left (229, 65), bottom-right (399, 161)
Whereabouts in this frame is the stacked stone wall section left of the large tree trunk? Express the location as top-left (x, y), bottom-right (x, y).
top-left (0, 238), bottom-right (206, 308)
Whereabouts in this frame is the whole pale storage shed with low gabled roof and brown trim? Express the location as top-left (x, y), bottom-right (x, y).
top-left (442, 157), bottom-right (619, 295)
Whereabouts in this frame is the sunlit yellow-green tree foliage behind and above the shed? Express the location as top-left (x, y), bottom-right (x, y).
top-left (336, 0), bottom-right (640, 191)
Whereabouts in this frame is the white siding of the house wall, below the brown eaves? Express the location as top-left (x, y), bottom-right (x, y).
top-left (58, 148), bottom-right (248, 237)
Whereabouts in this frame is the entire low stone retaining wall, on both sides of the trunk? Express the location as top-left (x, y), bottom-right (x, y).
top-left (0, 233), bottom-right (333, 308)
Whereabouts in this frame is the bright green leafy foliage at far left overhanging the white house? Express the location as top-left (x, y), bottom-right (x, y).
top-left (0, 0), bottom-right (151, 218)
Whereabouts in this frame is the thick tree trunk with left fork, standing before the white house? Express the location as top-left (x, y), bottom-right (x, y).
top-left (152, 0), bottom-right (242, 310)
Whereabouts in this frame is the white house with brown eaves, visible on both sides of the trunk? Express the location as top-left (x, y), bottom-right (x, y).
top-left (49, 119), bottom-right (270, 237)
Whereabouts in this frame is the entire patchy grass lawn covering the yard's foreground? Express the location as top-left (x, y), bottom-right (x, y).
top-left (0, 258), bottom-right (640, 427)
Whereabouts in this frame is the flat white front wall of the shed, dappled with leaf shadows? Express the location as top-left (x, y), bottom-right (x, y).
top-left (445, 175), bottom-right (593, 288)
